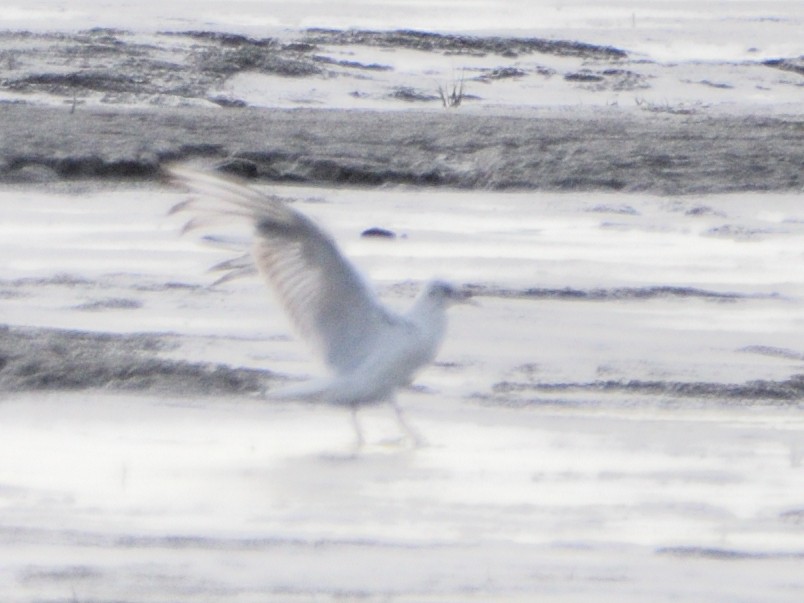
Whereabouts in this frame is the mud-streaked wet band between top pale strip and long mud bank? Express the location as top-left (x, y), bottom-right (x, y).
top-left (0, 22), bottom-right (804, 114)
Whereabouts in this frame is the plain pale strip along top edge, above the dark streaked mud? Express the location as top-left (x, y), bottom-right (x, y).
top-left (0, 0), bottom-right (804, 62)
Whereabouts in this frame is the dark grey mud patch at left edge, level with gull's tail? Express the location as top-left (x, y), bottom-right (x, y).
top-left (0, 326), bottom-right (276, 396)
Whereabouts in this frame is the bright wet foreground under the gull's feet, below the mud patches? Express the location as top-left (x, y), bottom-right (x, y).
top-left (0, 394), bottom-right (804, 601)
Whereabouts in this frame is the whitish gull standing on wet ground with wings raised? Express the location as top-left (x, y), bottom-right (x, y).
top-left (168, 166), bottom-right (470, 448)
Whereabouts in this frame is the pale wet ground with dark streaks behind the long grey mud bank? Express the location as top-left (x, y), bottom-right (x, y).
top-left (0, 0), bottom-right (804, 114)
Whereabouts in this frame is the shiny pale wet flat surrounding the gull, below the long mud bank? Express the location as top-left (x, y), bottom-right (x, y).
top-left (0, 184), bottom-right (804, 601)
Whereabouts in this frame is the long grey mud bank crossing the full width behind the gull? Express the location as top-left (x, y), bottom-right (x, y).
top-left (0, 105), bottom-right (804, 194)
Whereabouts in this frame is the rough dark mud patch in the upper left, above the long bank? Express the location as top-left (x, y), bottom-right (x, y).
top-left (0, 28), bottom-right (322, 105)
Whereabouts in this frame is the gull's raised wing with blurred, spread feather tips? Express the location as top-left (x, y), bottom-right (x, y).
top-left (169, 167), bottom-right (401, 373)
